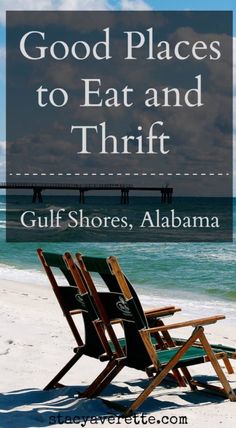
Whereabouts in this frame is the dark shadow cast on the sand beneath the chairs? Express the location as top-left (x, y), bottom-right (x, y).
top-left (0, 376), bottom-right (230, 428)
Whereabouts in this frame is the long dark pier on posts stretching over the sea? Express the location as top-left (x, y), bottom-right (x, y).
top-left (0, 183), bottom-right (173, 204)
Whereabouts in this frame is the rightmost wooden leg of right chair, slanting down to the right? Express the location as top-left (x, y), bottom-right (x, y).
top-left (199, 330), bottom-right (236, 401)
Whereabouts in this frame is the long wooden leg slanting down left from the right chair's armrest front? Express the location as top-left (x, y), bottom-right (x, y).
top-left (124, 327), bottom-right (201, 416)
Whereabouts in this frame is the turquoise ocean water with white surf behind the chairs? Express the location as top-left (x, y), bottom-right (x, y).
top-left (0, 195), bottom-right (236, 320)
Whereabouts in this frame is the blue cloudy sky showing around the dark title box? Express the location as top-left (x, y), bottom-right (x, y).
top-left (0, 0), bottom-right (236, 193)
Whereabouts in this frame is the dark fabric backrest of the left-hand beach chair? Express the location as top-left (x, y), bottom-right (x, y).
top-left (37, 249), bottom-right (105, 358)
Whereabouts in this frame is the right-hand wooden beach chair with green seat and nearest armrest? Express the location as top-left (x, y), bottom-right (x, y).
top-left (72, 255), bottom-right (236, 415)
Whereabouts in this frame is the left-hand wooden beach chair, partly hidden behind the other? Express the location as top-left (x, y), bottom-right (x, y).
top-left (37, 249), bottom-right (124, 390)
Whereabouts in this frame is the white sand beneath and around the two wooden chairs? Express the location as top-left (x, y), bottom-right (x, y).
top-left (0, 280), bottom-right (236, 428)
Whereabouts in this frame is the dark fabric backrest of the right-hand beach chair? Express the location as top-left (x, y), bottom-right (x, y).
top-left (76, 254), bottom-right (152, 370)
